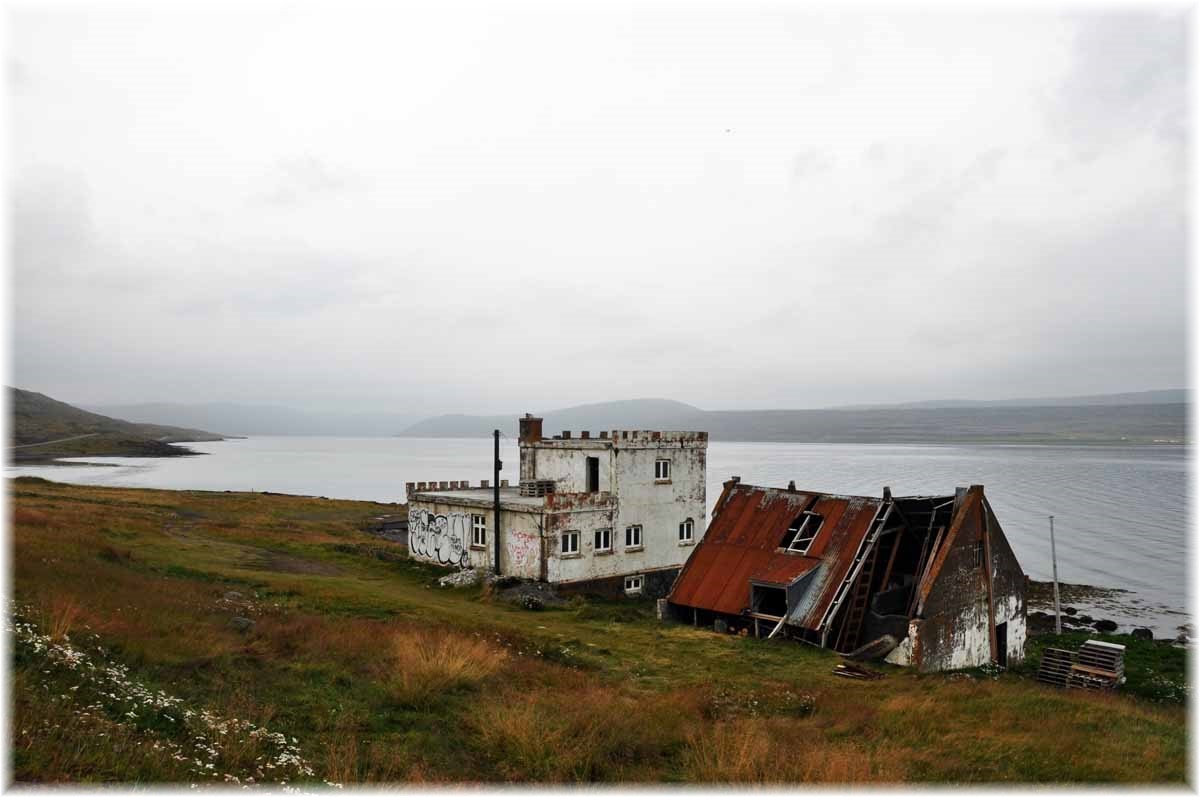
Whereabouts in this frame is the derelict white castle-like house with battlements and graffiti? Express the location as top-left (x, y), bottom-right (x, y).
top-left (406, 414), bottom-right (708, 597)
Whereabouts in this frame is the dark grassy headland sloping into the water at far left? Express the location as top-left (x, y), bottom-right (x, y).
top-left (10, 388), bottom-right (222, 462)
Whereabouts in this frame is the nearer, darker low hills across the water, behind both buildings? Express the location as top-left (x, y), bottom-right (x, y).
top-left (401, 390), bottom-right (1187, 443)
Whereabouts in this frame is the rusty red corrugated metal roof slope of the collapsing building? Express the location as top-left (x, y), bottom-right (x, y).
top-left (670, 484), bottom-right (883, 629)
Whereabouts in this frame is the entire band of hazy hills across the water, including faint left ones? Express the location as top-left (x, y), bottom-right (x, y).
top-left (68, 389), bottom-right (1190, 443)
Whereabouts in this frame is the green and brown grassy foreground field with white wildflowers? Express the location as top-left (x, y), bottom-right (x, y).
top-left (10, 479), bottom-right (1187, 784)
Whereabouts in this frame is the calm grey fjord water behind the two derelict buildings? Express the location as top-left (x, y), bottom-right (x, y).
top-left (7, 437), bottom-right (1188, 635)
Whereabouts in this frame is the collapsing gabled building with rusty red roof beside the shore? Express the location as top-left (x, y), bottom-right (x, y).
top-left (667, 478), bottom-right (1026, 671)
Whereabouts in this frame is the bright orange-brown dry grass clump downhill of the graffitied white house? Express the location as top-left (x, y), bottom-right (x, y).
top-left (385, 630), bottom-right (509, 706)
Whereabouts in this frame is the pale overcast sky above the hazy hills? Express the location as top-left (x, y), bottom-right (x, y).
top-left (7, 2), bottom-right (1187, 413)
